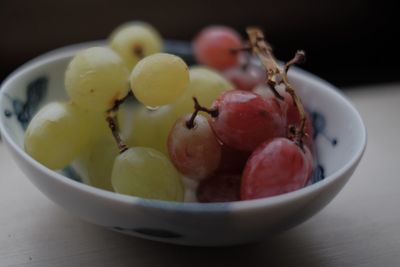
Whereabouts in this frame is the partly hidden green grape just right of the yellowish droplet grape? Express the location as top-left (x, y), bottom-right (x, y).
top-left (171, 66), bottom-right (234, 118)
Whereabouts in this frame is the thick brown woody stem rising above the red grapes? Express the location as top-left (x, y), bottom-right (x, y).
top-left (246, 27), bottom-right (306, 149)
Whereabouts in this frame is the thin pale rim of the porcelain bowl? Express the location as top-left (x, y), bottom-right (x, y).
top-left (0, 40), bottom-right (367, 212)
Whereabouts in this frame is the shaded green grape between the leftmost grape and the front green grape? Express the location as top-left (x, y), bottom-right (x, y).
top-left (86, 134), bottom-right (119, 191)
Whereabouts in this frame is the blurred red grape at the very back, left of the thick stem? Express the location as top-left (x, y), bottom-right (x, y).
top-left (193, 26), bottom-right (242, 70)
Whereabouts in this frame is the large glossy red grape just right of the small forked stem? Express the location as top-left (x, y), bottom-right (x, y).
top-left (211, 90), bottom-right (286, 151)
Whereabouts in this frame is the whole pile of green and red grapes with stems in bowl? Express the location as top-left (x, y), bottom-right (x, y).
top-left (24, 22), bottom-right (313, 202)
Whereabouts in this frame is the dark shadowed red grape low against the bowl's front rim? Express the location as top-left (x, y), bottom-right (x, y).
top-left (196, 173), bottom-right (240, 202)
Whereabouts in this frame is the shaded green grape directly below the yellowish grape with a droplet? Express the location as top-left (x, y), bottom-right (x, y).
top-left (126, 106), bottom-right (177, 155)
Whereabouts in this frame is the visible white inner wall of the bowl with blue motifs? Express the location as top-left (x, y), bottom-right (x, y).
top-left (0, 43), bottom-right (366, 197)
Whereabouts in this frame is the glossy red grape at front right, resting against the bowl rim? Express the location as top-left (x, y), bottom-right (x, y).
top-left (240, 138), bottom-right (312, 200)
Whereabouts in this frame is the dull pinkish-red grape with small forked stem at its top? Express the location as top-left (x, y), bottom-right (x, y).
top-left (168, 115), bottom-right (221, 180)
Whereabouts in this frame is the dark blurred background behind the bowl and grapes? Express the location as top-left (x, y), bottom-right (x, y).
top-left (0, 0), bottom-right (400, 86)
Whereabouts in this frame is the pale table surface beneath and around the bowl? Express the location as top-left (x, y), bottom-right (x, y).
top-left (0, 84), bottom-right (400, 267)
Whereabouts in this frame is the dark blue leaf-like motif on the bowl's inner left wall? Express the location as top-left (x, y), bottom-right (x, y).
top-left (4, 76), bottom-right (48, 129)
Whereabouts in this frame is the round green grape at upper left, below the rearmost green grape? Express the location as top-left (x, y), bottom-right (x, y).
top-left (65, 47), bottom-right (129, 111)
